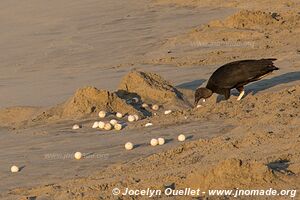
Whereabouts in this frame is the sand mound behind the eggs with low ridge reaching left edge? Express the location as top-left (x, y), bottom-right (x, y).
top-left (0, 87), bottom-right (143, 128)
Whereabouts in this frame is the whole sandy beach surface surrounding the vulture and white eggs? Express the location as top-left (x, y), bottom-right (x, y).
top-left (0, 0), bottom-right (300, 199)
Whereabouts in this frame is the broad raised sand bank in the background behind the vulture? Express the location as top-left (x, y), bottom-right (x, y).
top-left (146, 9), bottom-right (300, 66)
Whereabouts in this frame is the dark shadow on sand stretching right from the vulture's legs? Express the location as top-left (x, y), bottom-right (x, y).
top-left (247, 71), bottom-right (300, 94)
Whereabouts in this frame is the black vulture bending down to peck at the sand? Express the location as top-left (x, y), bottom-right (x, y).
top-left (195, 58), bottom-right (279, 106)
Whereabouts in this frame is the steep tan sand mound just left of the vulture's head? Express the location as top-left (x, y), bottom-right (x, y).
top-left (118, 70), bottom-right (186, 106)
